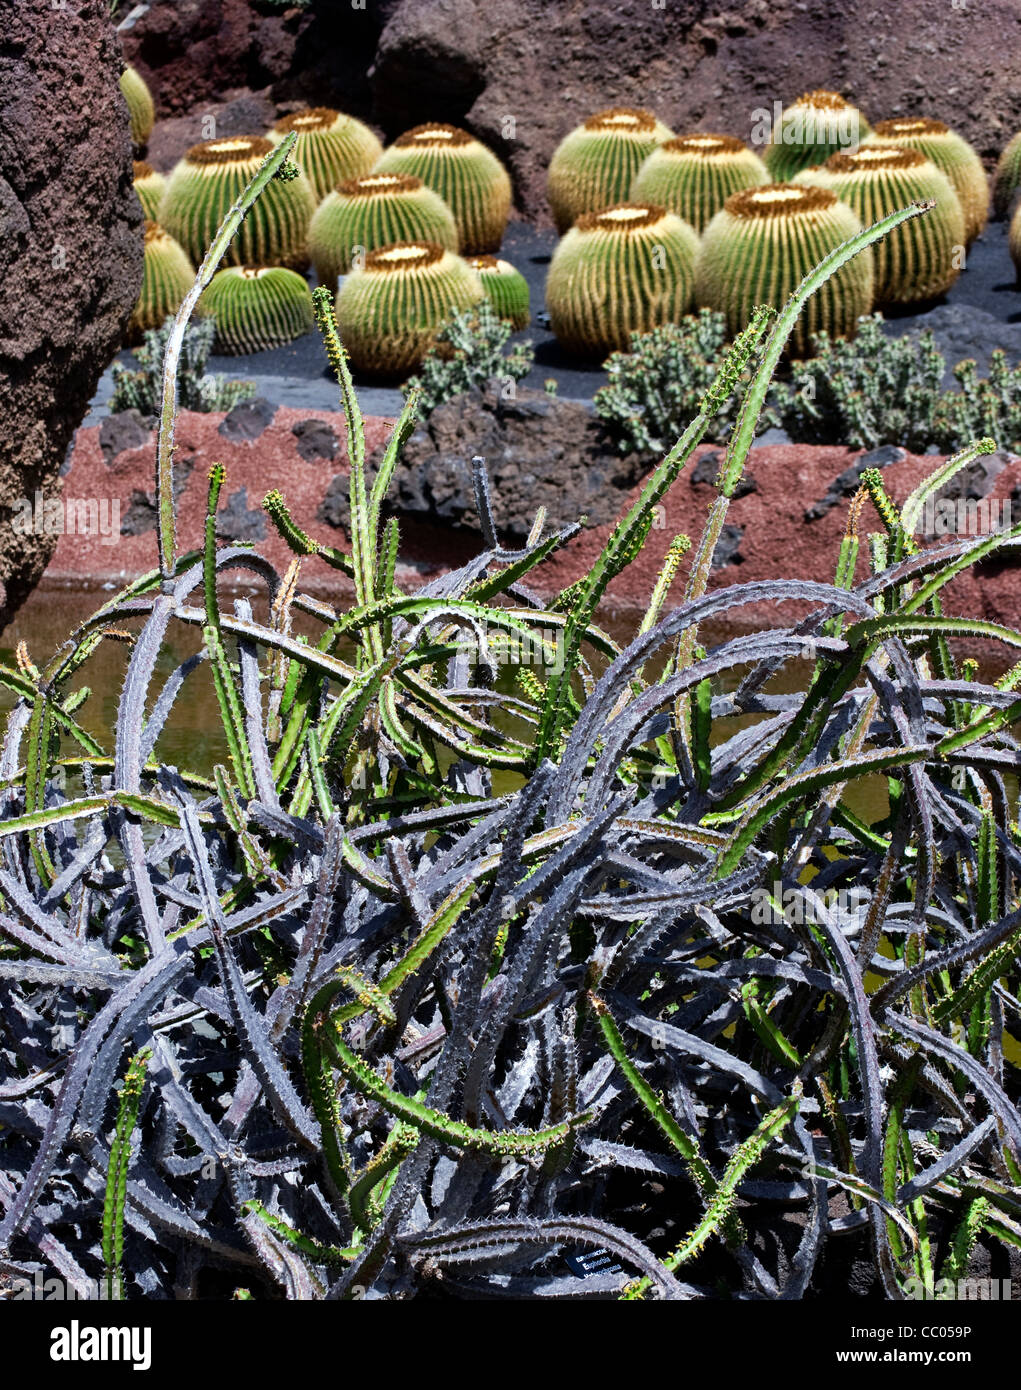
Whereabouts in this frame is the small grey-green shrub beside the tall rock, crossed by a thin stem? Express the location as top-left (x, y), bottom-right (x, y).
top-left (110, 318), bottom-right (256, 416)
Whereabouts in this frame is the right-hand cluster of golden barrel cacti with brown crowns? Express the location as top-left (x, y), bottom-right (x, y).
top-left (547, 89), bottom-right (1005, 356)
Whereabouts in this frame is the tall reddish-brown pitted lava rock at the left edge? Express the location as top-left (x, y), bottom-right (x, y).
top-left (0, 0), bottom-right (142, 628)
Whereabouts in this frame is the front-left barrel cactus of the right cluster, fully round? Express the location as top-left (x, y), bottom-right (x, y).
top-left (546, 203), bottom-right (699, 357)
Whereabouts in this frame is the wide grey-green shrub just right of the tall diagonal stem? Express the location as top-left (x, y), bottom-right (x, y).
top-left (774, 314), bottom-right (946, 453)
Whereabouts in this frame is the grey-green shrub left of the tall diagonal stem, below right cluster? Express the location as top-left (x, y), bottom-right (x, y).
top-left (595, 309), bottom-right (761, 455)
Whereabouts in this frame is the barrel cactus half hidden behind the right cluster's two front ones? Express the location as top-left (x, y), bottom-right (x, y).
top-left (631, 133), bottom-right (770, 232)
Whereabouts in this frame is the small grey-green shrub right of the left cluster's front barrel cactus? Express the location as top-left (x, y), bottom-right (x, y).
top-left (404, 299), bottom-right (535, 416)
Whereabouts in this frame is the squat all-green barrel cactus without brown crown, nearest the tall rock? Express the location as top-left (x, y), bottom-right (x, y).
top-left (199, 265), bottom-right (315, 356)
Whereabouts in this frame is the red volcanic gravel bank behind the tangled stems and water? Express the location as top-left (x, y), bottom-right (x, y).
top-left (46, 407), bottom-right (1021, 627)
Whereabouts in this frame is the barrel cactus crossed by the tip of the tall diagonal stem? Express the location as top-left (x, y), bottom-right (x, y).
top-left (795, 145), bottom-right (964, 306)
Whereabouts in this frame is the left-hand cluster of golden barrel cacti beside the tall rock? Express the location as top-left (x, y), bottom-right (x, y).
top-left (125, 96), bottom-right (529, 374)
